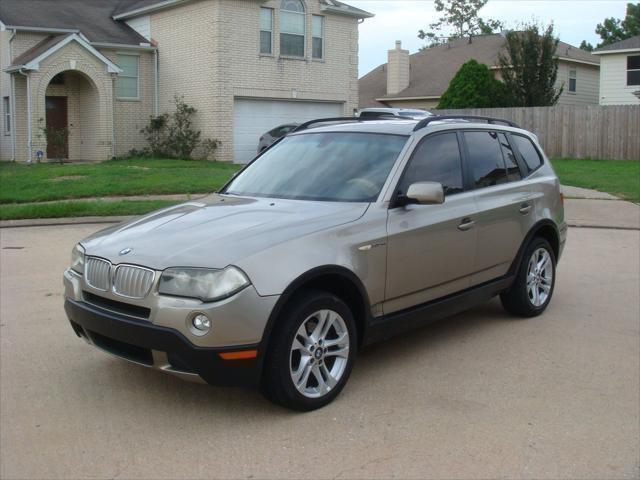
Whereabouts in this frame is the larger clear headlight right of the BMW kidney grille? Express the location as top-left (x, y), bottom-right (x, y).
top-left (158, 267), bottom-right (251, 302)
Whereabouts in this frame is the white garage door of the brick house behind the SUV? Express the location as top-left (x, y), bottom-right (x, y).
top-left (233, 98), bottom-right (343, 163)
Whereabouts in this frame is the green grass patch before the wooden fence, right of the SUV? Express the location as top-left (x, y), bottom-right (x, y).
top-left (552, 158), bottom-right (640, 203)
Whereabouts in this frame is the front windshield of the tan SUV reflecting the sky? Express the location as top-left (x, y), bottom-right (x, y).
top-left (221, 132), bottom-right (408, 202)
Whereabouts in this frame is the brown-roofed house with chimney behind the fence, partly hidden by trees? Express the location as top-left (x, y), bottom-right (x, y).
top-left (359, 34), bottom-right (600, 109)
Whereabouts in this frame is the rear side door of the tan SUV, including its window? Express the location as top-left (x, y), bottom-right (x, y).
top-left (463, 130), bottom-right (533, 286)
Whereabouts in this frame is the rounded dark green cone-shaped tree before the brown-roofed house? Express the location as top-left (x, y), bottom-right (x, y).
top-left (438, 60), bottom-right (512, 109)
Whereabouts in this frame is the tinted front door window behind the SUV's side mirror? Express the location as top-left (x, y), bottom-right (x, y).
top-left (399, 133), bottom-right (463, 195)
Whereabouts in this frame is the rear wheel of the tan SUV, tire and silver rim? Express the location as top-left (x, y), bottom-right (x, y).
top-left (500, 237), bottom-right (556, 318)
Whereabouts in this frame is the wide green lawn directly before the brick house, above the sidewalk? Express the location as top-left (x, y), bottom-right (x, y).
top-left (0, 158), bottom-right (240, 205)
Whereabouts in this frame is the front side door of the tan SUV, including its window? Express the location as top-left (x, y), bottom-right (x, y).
top-left (383, 131), bottom-right (477, 314)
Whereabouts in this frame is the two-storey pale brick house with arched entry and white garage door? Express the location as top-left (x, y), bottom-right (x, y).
top-left (0, 0), bottom-right (372, 162)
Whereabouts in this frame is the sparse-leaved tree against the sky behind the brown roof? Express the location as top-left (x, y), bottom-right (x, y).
top-left (418, 0), bottom-right (503, 48)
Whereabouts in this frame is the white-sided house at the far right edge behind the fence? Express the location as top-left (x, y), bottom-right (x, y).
top-left (593, 35), bottom-right (640, 105)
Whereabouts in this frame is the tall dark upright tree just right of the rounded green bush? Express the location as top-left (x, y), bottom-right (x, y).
top-left (498, 24), bottom-right (563, 107)
